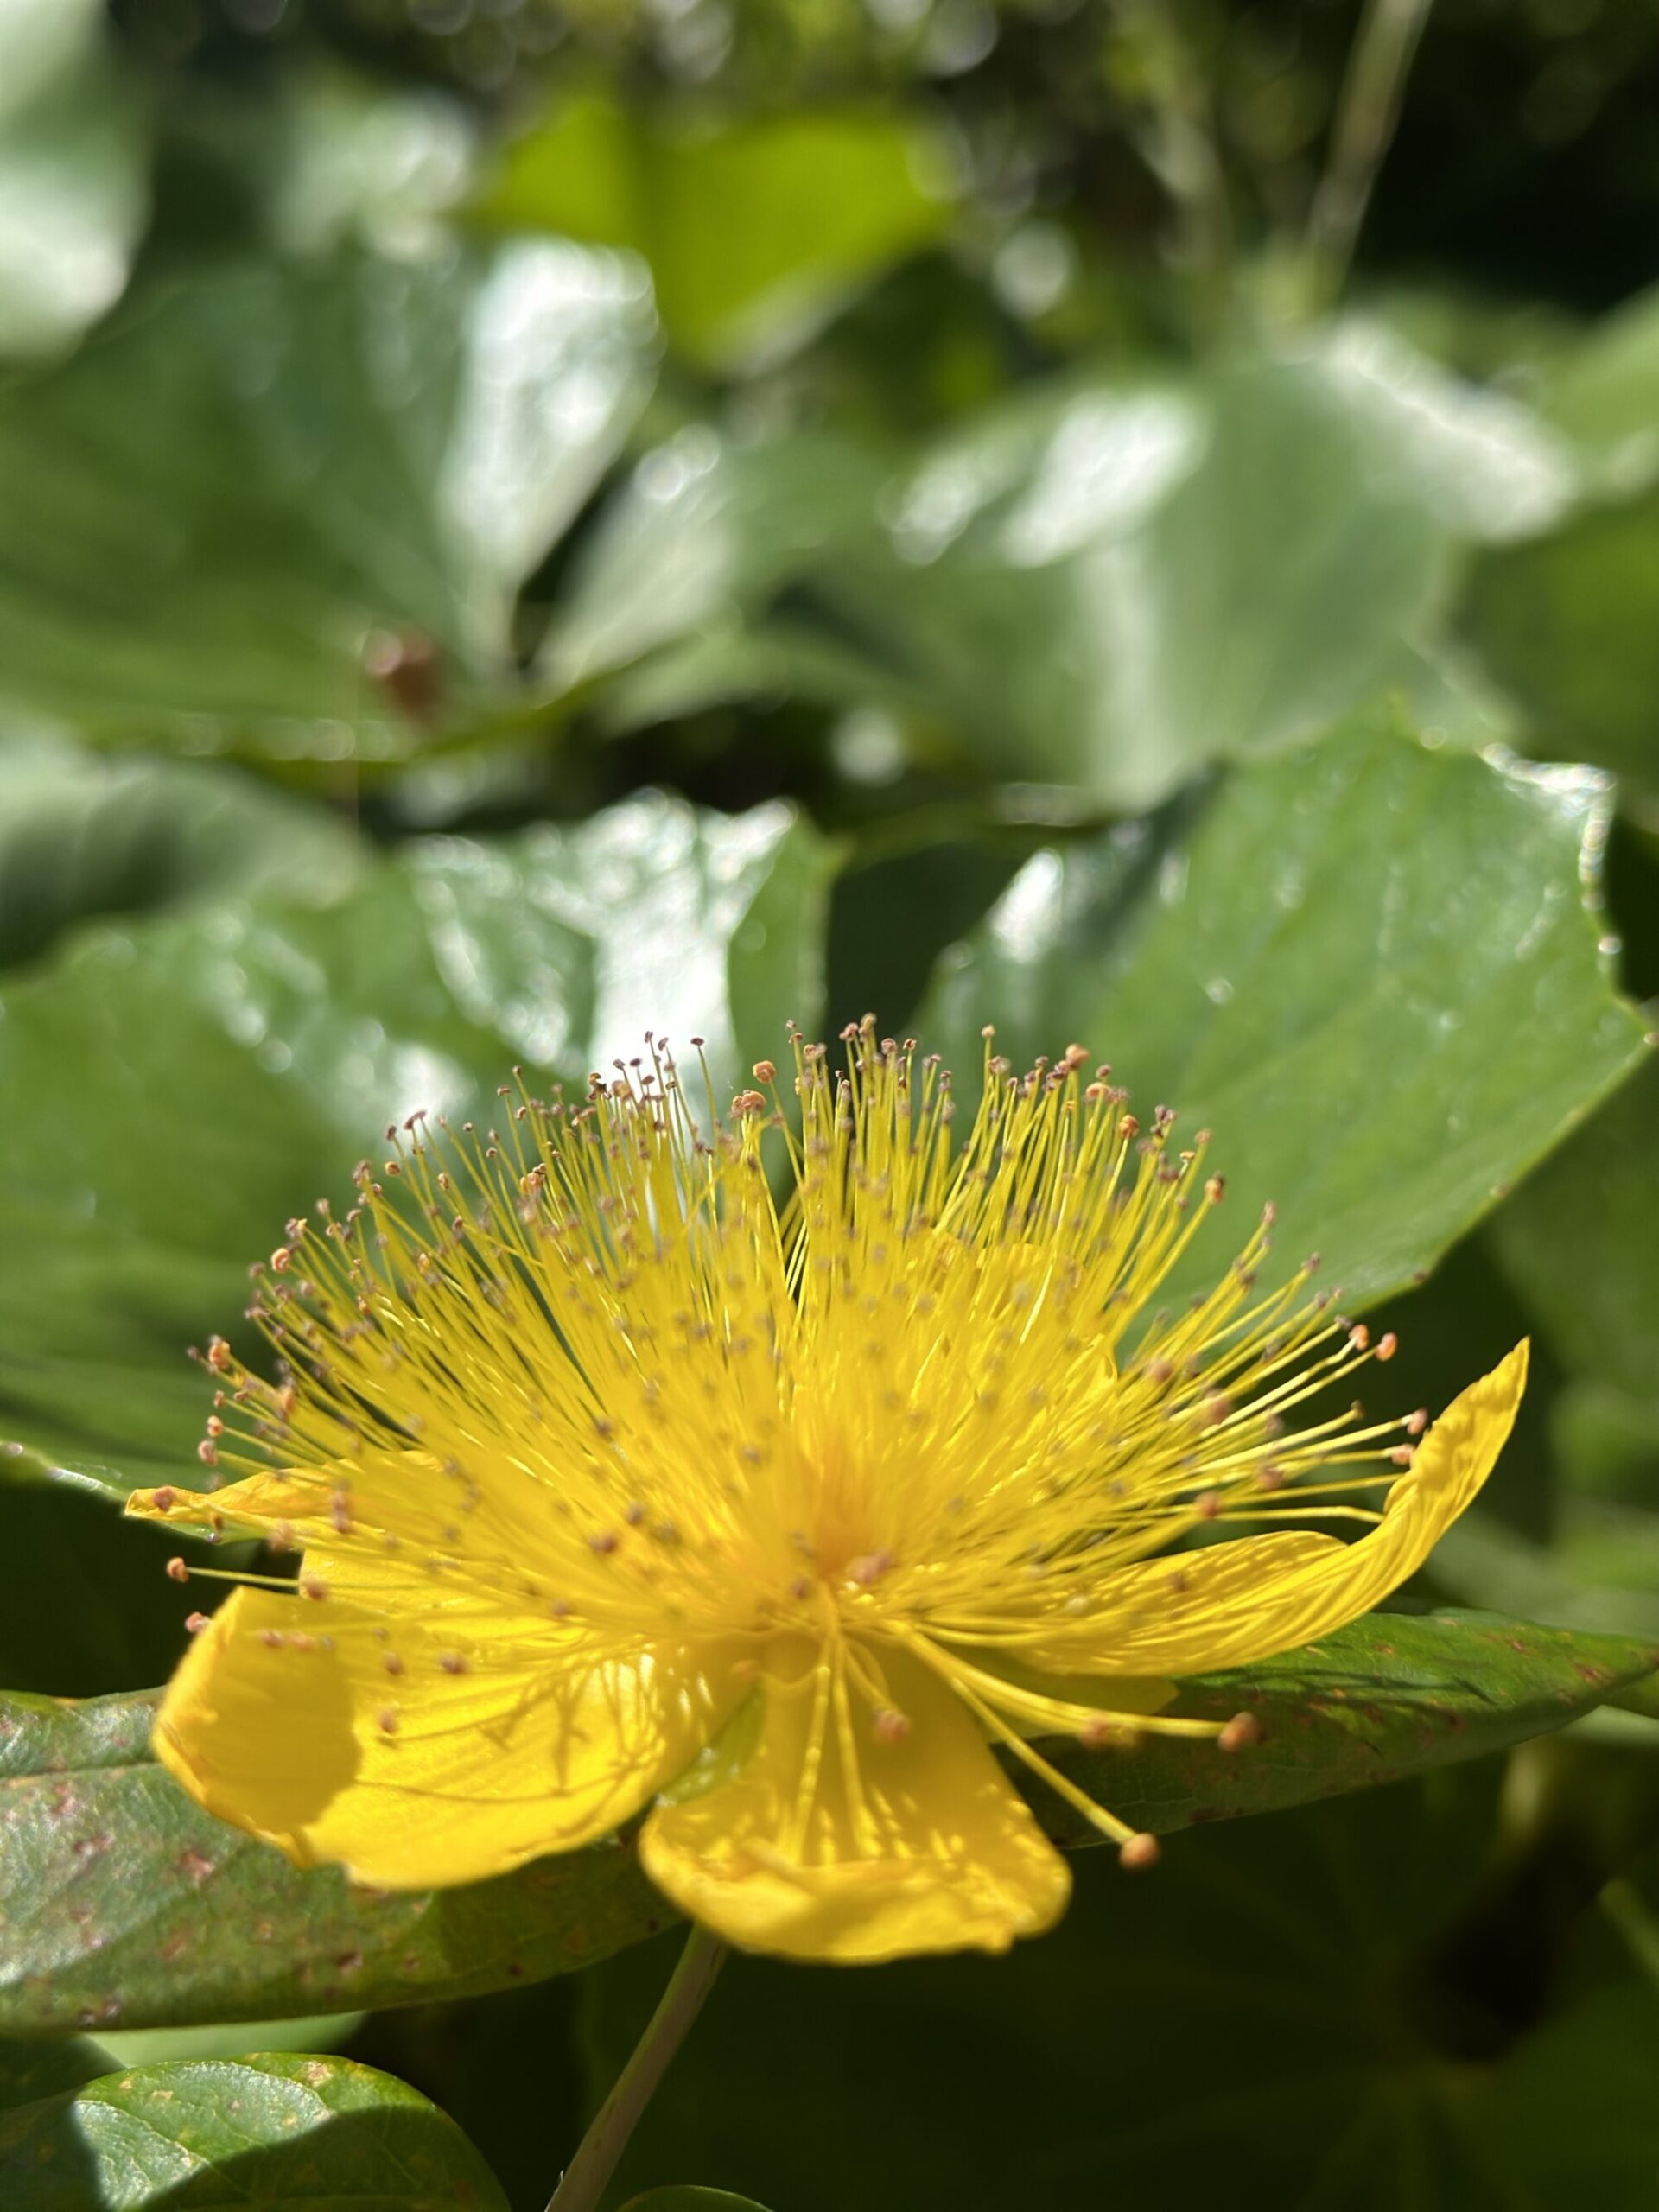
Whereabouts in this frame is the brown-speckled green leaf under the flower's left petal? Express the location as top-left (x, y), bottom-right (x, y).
top-left (0, 1697), bottom-right (672, 2035)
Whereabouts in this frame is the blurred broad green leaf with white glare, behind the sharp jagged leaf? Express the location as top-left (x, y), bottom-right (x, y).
top-left (549, 325), bottom-right (1577, 810)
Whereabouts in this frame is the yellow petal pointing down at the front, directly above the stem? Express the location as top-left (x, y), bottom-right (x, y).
top-left (639, 1652), bottom-right (1071, 1962)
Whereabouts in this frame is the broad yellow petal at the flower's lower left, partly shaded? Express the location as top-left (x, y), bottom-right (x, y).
top-left (155, 1588), bottom-right (743, 1889)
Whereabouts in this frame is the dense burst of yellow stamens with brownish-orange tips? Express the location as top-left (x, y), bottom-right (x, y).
top-left (172, 1020), bottom-right (1422, 1865)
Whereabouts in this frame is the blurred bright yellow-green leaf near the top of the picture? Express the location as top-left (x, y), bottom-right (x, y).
top-left (474, 95), bottom-right (951, 367)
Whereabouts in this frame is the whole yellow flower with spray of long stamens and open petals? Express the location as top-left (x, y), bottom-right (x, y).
top-left (130, 1022), bottom-right (1526, 1960)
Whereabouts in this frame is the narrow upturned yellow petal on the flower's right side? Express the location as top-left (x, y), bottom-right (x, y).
top-left (1000, 1343), bottom-right (1526, 1701)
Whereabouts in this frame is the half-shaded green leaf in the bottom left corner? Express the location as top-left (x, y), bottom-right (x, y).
top-left (0, 2055), bottom-right (506, 2212)
